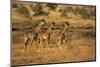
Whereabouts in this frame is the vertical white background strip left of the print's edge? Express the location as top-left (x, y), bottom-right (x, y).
top-left (0, 0), bottom-right (10, 67)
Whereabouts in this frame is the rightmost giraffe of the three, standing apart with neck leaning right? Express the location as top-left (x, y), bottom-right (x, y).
top-left (56, 22), bottom-right (69, 47)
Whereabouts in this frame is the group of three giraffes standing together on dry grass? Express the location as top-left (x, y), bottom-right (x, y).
top-left (24, 19), bottom-right (69, 51)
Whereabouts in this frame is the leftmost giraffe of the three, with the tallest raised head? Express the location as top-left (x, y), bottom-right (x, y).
top-left (24, 19), bottom-right (45, 51)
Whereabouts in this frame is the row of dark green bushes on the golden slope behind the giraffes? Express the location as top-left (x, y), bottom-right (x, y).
top-left (12, 2), bottom-right (96, 19)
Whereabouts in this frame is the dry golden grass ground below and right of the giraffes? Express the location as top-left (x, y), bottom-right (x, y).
top-left (12, 29), bottom-right (96, 65)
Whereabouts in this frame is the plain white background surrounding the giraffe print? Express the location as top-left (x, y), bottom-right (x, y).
top-left (0, 0), bottom-right (100, 67)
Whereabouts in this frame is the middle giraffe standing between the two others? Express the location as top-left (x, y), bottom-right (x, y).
top-left (39, 22), bottom-right (54, 46)
